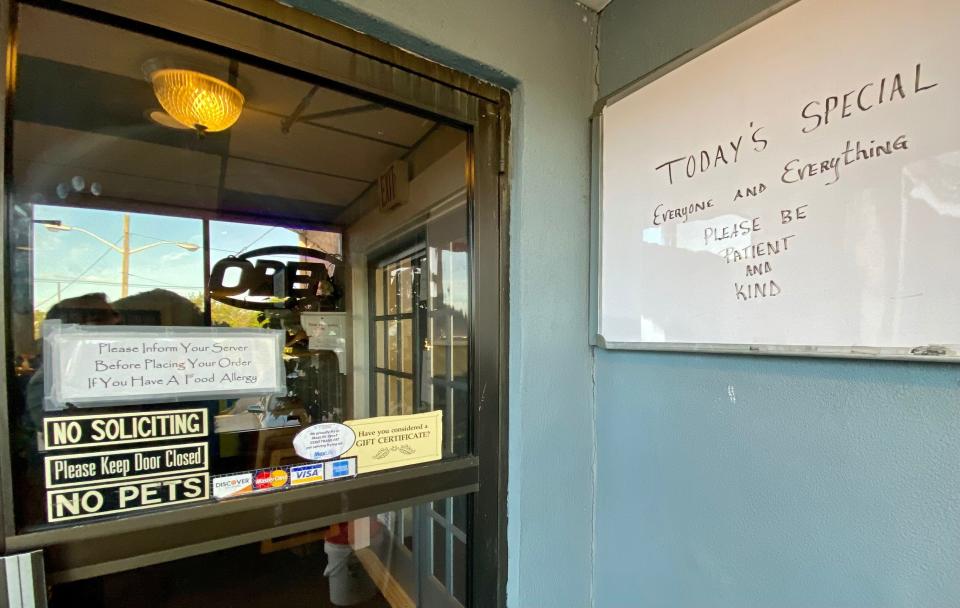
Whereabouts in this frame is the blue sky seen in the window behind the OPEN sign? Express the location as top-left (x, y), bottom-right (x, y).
top-left (33, 205), bottom-right (298, 311)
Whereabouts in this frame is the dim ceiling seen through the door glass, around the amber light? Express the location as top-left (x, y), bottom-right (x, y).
top-left (13, 6), bottom-right (435, 228)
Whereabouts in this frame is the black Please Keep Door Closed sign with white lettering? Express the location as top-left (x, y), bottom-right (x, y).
top-left (44, 443), bottom-right (208, 489)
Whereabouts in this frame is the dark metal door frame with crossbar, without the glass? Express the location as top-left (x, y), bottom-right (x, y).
top-left (0, 0), bottom-right (510, 608)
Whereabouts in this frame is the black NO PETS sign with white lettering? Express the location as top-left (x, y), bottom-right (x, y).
top-left (47, 473), bottom-right (210, 523)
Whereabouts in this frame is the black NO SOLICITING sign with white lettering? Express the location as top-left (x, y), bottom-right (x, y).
top-left (43, 408), bottom-right (209, 450)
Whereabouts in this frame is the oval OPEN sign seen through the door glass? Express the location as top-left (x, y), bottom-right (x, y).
top-left (208, 245), bottom-right (343, 310)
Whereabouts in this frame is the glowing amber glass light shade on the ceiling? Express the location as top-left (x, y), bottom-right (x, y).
top-left (150, 69), bottom-right (243, 133)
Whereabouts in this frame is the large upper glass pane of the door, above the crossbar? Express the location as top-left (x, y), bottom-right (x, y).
top-left (2, 3), bottom-right (470, 532)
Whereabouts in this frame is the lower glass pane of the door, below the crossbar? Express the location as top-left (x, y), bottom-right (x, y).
top-left (49, 496), bottom-right (469, 608)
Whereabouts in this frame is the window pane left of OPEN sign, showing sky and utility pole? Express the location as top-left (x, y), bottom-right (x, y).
top-left (29, 205), bottom-right (204, 325)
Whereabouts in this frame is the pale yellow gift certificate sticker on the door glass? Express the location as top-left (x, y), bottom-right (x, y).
top-left (343, 410), bottom-right (443, 473)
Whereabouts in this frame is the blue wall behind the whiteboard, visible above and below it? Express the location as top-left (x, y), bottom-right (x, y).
top-left (592, 0), bottom-right (960, 608)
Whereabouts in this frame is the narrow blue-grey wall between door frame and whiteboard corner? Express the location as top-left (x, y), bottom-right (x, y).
top-left (278, 0), bottom-right (596, 607)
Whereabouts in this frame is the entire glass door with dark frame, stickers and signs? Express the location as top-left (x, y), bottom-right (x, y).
top-left (0, 0), bottom-right (505, 607)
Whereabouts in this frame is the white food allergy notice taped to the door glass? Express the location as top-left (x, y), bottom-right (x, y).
top-left (43, 321), bottom-right (286, 410)
